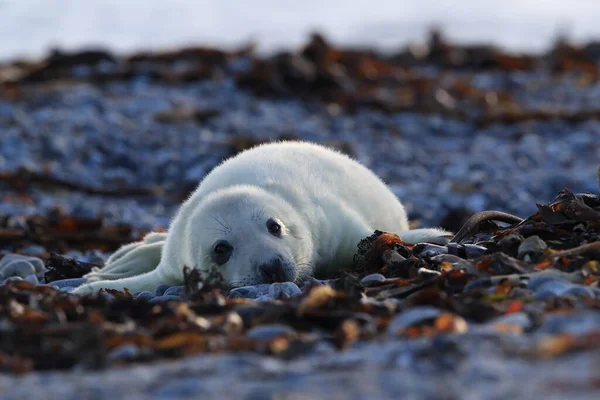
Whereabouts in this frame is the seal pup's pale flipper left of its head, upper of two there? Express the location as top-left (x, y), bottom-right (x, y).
top-left (85, 232), bottom-right (166, 282)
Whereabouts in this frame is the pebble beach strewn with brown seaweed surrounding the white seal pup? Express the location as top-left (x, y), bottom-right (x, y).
top-left (0, 33), bottom-right (600, 398)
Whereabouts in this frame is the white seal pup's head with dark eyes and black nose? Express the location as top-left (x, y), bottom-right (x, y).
top-left (181, 186), bottom-right (313, 287)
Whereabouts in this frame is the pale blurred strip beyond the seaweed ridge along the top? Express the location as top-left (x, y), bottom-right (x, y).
top-left (0, 0), bottom-right (600, 59)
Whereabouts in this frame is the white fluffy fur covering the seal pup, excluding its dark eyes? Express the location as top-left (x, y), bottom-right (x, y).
top-left (76, 142), bottom-right (449, 293)
